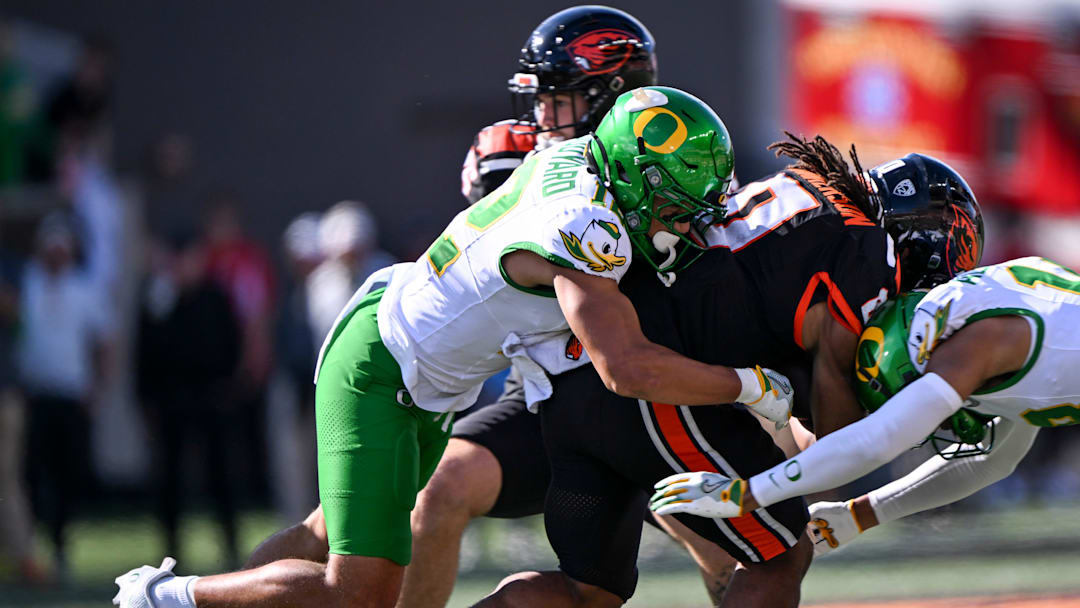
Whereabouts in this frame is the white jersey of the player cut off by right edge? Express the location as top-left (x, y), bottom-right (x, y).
top-left (907, 257), bottom-right (1080, 427)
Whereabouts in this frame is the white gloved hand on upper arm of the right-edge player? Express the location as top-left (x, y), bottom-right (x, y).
top-left (649, 471), bottom-right (746, 518)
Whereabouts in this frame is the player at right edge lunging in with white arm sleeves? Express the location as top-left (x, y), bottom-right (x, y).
top-left (652, 257), bottom-right (1080, 554)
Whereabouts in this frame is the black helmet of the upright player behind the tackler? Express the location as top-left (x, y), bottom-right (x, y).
top-left (510, 5), bottom-right (657, 136)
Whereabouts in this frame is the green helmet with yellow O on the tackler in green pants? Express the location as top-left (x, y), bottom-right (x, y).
top-left (590, 86), bottom-right (734, 273)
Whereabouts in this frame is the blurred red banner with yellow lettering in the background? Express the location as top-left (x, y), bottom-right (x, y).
top-left (786, 2), bottom-right (1080, 214)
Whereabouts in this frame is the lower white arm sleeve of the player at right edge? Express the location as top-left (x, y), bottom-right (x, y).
top-left (868, 418), bottom-right (1039, 524)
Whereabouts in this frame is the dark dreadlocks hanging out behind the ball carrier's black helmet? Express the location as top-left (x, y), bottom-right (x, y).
top-left (769, 131), bottom-right (882, 222)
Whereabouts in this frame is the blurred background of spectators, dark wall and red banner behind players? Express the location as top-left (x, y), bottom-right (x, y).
top-left (0, 0), bottom-right (1080, 600)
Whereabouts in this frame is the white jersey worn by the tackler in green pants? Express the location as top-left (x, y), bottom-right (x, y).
top-left (378, 137), bottom-right (631, 411)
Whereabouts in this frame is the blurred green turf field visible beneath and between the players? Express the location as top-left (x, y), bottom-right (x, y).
top-left (6, 503), bottom-right (1080, 608)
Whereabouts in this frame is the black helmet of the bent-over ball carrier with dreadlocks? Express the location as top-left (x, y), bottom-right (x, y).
top-left (867, 154), bottom-right (983, 292)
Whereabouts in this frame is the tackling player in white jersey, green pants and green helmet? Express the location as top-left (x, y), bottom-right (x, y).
top-left (113, 86), bottom-right (791, 608)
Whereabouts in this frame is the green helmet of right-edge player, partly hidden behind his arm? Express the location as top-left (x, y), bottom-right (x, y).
top-left (855, 291), bottom-right (994, 458)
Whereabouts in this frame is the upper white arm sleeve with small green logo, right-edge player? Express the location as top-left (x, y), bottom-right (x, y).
top-left (750, 374), bottom-right (963, 506)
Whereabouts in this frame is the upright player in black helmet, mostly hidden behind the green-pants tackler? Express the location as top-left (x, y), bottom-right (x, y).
top-left (230, 10), bottom-right (751, 608)
